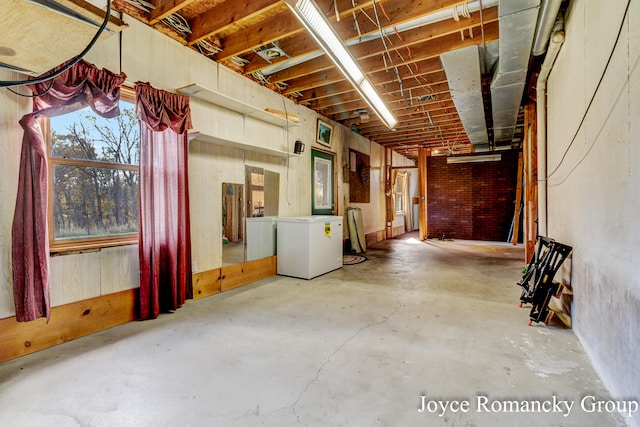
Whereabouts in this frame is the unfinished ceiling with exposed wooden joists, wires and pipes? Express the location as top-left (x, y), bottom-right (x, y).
top-left (119, 0), bottom-right (539, 158)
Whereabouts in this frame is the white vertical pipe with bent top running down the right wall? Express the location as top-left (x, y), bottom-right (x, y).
top-left (536, 25), bottom-right (564, 236)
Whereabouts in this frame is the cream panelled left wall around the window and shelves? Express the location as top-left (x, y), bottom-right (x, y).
top-left (0, 17), bottom-right (410, 318)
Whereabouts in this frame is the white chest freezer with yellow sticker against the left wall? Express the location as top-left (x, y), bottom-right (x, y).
top-left (276, 215), bottom-right (342, 279)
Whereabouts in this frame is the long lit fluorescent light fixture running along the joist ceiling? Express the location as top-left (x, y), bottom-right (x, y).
top-left (285, 0), bottom-right (398, 129)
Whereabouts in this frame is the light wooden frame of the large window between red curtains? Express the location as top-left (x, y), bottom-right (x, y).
top-left (47, 86), bottom-right (140, 254)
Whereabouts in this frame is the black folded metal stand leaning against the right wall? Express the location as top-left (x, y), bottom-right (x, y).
top-left (517, 236), bottom-right (572, 324)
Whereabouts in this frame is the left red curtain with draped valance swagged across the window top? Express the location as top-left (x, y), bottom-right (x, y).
top-left (12, 61), bottom-right (126, 322)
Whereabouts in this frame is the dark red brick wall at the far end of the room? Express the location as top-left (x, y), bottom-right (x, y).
top-left (427, 151), bottom-right (518, 242)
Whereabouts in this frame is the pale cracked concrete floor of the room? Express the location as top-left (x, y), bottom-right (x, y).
top-left (0, 238), bottom-right (624, 427)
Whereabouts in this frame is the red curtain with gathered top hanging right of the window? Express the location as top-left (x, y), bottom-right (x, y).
top-left (136, 82), bottom-right (193, 319)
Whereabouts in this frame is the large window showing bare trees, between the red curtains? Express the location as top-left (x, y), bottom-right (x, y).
top-left (48, 91), bottom-right (140, 251)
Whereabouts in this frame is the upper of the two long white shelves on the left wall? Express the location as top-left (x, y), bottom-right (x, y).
top-left (178, 83), bottom-right (300, 127)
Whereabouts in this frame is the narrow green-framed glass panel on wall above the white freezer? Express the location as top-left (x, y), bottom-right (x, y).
top-left (311, 150), bottom-right (334, 215)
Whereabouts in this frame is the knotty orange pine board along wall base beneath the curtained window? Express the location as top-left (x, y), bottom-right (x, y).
top-left (0, 289), bottom-right (138, 363)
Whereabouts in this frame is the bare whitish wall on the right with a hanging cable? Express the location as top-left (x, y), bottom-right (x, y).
top-left (547, 0), bottom-right (640, 418)
